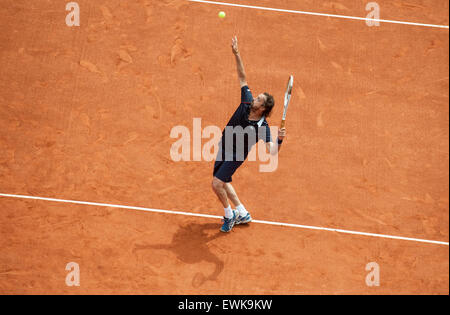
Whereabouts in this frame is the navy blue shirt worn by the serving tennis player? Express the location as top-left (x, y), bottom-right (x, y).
top-left (219, 86), bottom-right (272, 162)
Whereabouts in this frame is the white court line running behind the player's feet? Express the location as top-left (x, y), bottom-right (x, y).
top-left (0, 194), bottom-right (449, 246)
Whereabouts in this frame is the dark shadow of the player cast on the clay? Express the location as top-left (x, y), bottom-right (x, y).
top-left (133, 223), bottom-right (225, 287)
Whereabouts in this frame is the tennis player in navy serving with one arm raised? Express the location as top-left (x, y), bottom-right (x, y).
top-left (212, 36), bottom-right (286, 232)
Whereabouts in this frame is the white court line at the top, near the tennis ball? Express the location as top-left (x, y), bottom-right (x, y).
top-left (188, 0), bottom-right (449, 29)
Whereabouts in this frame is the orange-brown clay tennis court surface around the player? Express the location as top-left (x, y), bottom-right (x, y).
top-left (0, 0), bottom-right (449, 295)
